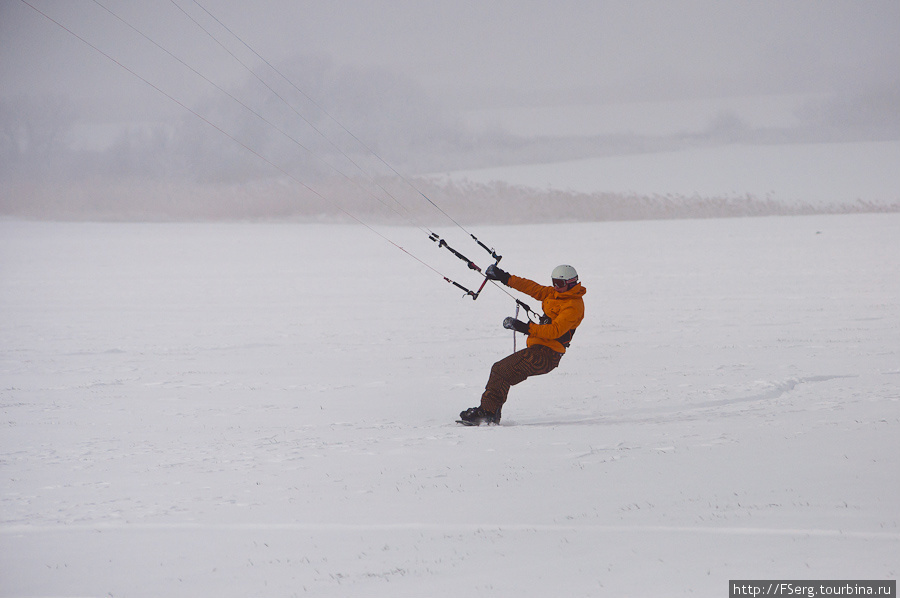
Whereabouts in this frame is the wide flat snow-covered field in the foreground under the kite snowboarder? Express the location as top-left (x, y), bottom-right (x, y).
top-left (0, 214), bottom-right (900, 598)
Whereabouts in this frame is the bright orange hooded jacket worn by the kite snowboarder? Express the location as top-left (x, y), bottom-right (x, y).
top-left (509, 276), bottom-right (587, 353)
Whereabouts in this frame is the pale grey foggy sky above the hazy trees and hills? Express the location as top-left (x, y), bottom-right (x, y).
top-left (0, 0), bottom-right (900, 116)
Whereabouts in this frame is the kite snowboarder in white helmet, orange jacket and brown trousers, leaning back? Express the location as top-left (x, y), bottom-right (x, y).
top-left (459, 265), bottom-right (586, 426)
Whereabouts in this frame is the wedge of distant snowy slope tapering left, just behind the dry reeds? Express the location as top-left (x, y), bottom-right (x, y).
top-left (434, 141), bottom-right (900, 206)
